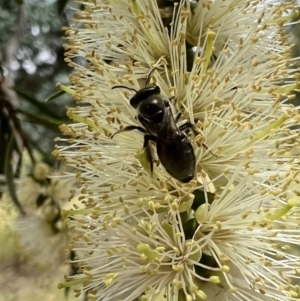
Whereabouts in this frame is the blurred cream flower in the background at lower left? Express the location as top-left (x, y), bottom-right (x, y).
top-left (2, 163), bottom-right (74, 274)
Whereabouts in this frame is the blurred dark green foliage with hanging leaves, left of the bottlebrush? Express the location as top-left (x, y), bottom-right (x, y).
top-left (0, 0), bottom-right (72, 212)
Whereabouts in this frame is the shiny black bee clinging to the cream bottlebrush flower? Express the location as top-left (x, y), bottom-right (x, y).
top-left (112, 70), bottom-right (198, 183)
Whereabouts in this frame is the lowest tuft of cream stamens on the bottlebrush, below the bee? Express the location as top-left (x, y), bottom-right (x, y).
top-left (60, 166), bottom-right (300, 301)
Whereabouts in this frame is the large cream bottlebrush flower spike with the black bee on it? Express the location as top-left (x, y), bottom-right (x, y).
top-left (54, 0), bottom-right (300, 301)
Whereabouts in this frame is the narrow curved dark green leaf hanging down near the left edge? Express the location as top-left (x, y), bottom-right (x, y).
top-left (4, 131), bottom-right (25, 215)
